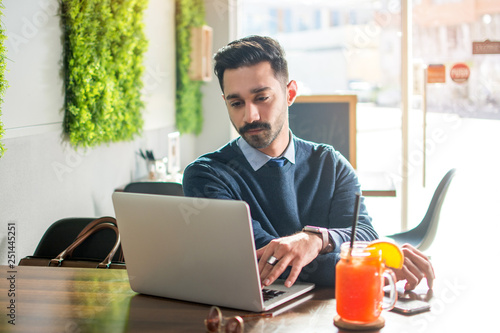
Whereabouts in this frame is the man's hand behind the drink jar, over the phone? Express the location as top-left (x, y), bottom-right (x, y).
top-left (394, 244), bottom-right (435, 290)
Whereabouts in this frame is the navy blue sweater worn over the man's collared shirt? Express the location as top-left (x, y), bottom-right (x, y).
top-left (183, 136), bottom-right (378, 286)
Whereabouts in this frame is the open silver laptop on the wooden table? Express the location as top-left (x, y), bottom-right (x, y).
top-left (112, 192), bottom-right (314, 312)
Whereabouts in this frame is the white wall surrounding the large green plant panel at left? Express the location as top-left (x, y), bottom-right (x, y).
top-left (0, 0), bottom-right (178, 264)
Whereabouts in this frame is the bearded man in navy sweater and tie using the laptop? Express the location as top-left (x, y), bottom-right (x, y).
top-left (183, 36), bottom-right (434, 289)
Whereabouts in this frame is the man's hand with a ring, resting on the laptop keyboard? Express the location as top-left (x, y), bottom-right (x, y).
top-left (257, 232), bottom-right (323, 287)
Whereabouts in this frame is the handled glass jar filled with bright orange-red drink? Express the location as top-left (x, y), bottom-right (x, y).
top-left (335, 242), bottom-right (397, 324)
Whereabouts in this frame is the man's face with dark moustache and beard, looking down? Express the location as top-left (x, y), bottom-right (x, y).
top-left (223, 62), bottom-right (293, 152)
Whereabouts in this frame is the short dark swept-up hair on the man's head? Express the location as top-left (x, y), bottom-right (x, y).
top-left (214, 36), bottom-right (288, 92)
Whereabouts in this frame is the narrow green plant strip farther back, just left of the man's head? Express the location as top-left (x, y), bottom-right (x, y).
top-left (175, 0), bottom-right (205, 134)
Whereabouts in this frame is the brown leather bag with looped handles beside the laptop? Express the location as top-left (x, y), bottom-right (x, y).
top-left (19, 217), bottom-right (126, 269)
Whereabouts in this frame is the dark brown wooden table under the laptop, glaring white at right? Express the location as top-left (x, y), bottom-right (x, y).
top-left (0, 256), bottom-right (499, 333)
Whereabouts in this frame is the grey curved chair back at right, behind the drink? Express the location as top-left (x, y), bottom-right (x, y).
top-left (386, 169), bottom-right (456, 251)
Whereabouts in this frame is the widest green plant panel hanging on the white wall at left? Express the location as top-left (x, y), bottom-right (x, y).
top-left (61, 0), bottom-right (148, 147)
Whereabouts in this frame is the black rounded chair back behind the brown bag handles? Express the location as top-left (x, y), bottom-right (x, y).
top-left (29, 217), bottom-right (121, 261)
